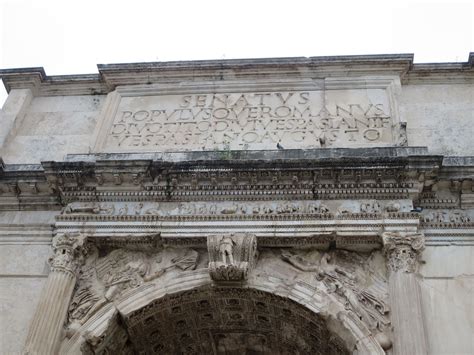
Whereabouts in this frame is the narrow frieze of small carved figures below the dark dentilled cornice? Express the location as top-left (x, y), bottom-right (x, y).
top-left (58, 199), bottom-right (412, 220)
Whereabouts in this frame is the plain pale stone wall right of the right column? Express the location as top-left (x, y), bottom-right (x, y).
top-left (421, 246), bottom-right (474, 355)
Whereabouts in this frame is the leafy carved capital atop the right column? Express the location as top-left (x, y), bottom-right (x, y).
top-left (382, 232), bottom-right (425, 272)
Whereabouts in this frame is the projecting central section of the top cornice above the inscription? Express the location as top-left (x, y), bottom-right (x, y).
top-left (94, 54), bottom-right (413, 88)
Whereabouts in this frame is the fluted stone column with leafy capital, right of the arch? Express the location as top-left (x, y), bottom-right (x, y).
top-left (382, 232), bottom-right (427, 355)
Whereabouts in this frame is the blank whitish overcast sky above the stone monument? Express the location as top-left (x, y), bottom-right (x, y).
top-left (0, 0), bottom-right (474, 102)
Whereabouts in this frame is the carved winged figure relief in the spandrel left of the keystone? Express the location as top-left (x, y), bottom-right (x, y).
top-left (68, 246), bottom-right (199, 335)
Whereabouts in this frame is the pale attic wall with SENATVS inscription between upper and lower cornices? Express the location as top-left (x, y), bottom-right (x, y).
top-left (0, 79), bottom-right (474, 163)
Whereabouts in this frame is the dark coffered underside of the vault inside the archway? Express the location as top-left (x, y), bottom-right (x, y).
top-left (123, 286), bottom-right (350, 355)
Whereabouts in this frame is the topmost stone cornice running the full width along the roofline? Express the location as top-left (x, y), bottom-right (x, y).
top-left (0, 53), bottom-right (474, 96)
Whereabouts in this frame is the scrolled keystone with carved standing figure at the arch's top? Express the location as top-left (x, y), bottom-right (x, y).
top-left (207, 234), bottom-right (257, 281)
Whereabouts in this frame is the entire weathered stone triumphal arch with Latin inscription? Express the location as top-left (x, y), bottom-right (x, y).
top-left (0, 53), bottom-right (474, 355)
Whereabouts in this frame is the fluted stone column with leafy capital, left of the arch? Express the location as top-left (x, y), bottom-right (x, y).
top-left (24, 234), bottom-right (86, 355)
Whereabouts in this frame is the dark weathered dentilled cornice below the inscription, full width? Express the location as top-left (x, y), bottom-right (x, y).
top-left (0, 147), bottom-right (474, 210)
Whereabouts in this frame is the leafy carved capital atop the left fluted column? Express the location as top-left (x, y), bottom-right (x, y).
top-left (49, 233), bottom-right (87, 274)
